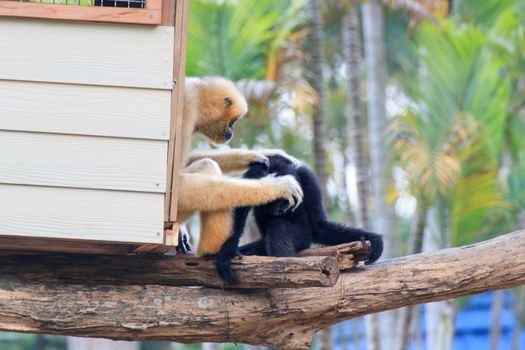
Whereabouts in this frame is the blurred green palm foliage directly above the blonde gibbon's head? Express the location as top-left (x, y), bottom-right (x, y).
top-left (186, 0), bottom-right (300, 81)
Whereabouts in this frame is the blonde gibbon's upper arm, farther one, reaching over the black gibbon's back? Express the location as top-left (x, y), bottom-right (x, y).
top-left (188, 148), bottom-right (267, 174)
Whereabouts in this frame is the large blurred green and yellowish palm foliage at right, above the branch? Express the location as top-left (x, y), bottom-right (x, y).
top-left (393, 13), bottom-right (512, 244)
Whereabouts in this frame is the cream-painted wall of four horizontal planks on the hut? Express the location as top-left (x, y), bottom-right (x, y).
top-left (0, 17), bottom-right (174, 243)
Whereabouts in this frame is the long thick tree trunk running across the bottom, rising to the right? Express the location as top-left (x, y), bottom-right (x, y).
top-left (0, 231), bottom-right (525, 349)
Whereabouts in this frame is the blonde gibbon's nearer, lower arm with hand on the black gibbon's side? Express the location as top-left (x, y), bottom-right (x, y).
top-left (175, 173), bottom-right (303, 215)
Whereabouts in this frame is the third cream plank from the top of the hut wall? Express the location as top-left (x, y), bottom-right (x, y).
top-left (0, 131), bottom-right (167, 193)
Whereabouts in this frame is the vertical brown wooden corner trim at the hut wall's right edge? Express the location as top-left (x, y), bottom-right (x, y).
top-left (164, 0), bottom-right (189, 221)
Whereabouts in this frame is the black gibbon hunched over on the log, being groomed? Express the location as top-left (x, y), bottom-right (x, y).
top-left (215, 155), bottom-right (383, 284)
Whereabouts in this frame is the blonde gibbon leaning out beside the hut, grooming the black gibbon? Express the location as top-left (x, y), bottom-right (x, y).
top-left (178, 77), bottom-right (303, 256)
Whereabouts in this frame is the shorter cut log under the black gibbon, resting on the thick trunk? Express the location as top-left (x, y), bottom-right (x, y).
top-left (0, 254), bottom-right (339, 288)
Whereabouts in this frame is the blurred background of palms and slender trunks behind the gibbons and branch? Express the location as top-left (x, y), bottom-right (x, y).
top-left (0, 0), bottom-right (525, 350)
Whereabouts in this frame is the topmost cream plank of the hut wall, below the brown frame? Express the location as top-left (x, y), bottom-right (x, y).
top-left (0, 18), bottom-right (174, 89)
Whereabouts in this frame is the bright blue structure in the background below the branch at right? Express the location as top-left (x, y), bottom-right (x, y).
top-left (334, 291), bottom-right (525, 350)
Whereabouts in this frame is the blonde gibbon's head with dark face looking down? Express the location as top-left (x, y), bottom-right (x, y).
top-left (196, 78), bottom-right (248, 143)
